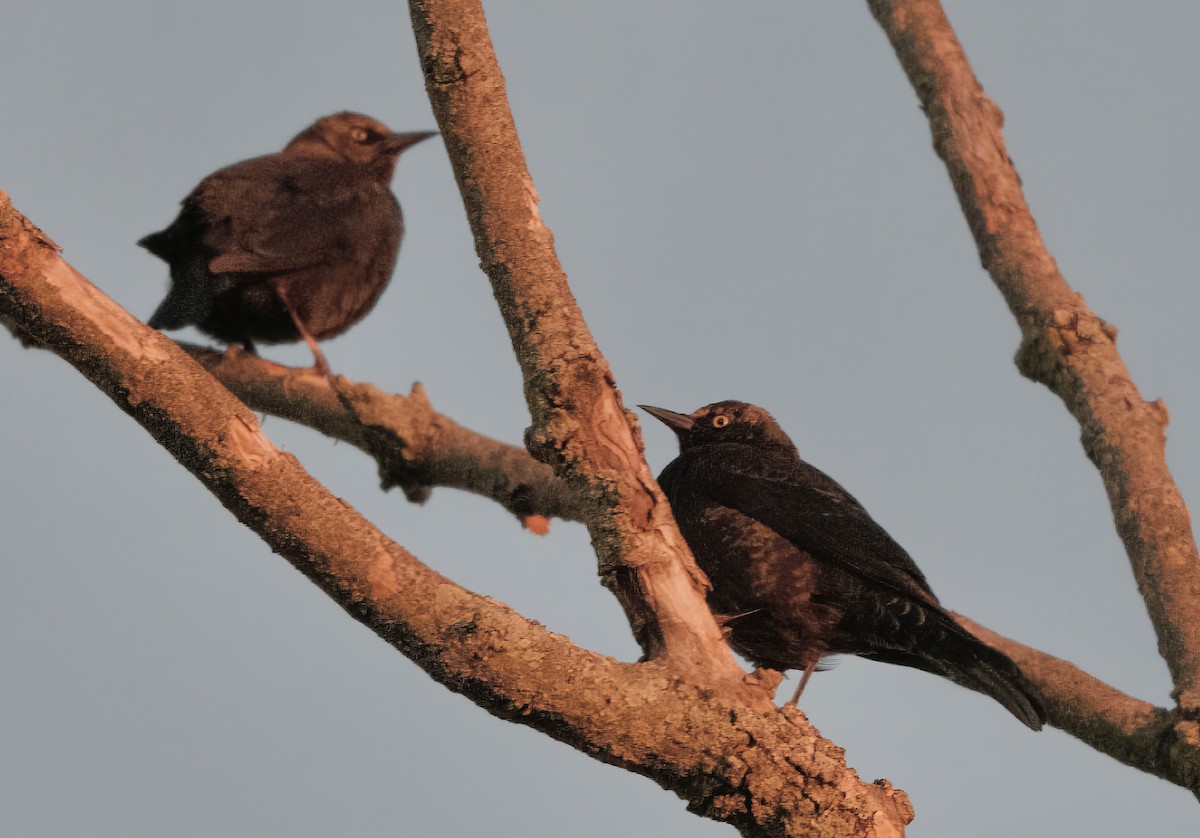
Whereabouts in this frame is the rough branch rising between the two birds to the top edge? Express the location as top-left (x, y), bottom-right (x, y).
top-left (410, 0), bottom-right (761, 686)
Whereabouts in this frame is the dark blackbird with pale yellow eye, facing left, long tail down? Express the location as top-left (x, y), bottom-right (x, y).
top-left (642, 401), bottom-right (1045, 730)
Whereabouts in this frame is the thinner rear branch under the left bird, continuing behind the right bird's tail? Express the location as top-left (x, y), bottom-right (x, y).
top-left (169, 333), bottom-right (1200, 796)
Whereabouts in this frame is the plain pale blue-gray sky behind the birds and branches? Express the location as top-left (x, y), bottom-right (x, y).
top-left (0, 0), bottom-right (1200, 838)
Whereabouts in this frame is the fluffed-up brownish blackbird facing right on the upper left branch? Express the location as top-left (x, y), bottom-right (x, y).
top-left (138, 112), bottom-right (433, 375)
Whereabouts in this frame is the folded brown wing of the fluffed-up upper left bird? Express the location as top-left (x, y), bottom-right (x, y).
top-left (185, 155), bottom-right (400, 274)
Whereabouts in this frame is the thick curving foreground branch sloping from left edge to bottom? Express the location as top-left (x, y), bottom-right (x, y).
top-left (0, 192), bottom-right (912, 837)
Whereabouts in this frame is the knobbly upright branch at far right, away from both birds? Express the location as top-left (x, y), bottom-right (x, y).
top-left (869, 0), bottom-right (1200, 714)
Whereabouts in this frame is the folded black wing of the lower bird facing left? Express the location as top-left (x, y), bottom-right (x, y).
top-left (688, 445), bottom-right (937, 603)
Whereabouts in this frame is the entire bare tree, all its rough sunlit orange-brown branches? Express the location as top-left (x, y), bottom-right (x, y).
top-left (0, 0), bottom-right (1200, 836)
